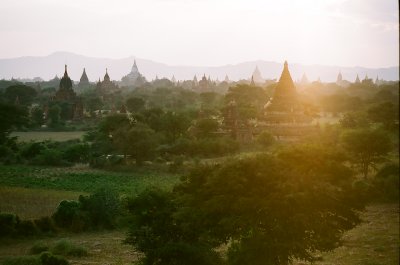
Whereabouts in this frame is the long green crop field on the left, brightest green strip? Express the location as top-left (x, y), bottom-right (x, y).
top-left (0, 165), bottom-right (179, 195)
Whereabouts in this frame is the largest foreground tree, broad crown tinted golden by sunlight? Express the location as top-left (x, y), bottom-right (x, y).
top-left (128, 146), bottom-right (362, 265)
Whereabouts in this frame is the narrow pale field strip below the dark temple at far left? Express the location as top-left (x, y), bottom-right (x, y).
top-left (11, 131), bottom-right (86, 142)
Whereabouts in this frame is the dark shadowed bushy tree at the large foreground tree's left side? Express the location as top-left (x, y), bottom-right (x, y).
top-left (125, 188), bottom-right (222, 265)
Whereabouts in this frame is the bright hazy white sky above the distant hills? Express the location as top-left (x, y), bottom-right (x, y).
top-left (0, 0), bottom-right (399, 67)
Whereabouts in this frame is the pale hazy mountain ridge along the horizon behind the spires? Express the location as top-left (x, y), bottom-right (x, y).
top-left (0, 52), bottom-right (399, 82)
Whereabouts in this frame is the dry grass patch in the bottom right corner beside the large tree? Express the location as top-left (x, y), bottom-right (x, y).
top-left (315, 204), bottom-right (400, 265)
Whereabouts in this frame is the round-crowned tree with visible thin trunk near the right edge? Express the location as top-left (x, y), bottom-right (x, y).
top-left (342, 129), bottom-right (391, 178)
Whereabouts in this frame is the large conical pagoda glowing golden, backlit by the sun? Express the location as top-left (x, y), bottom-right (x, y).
top-left (261, 61), bottom-right (312, 137)
